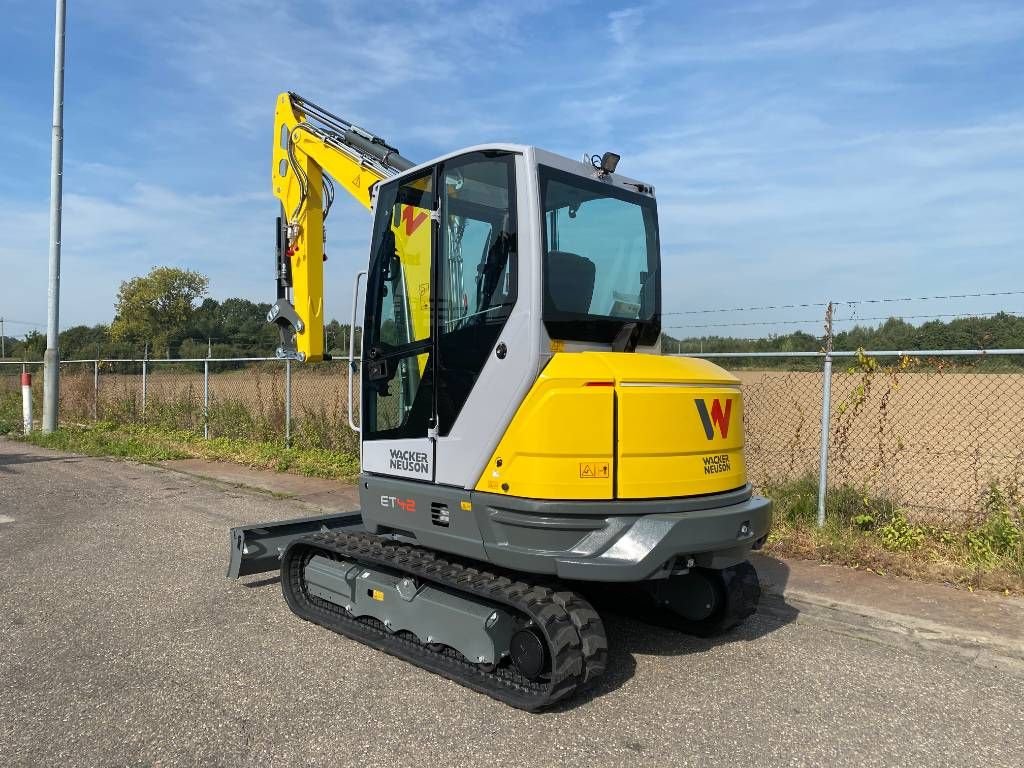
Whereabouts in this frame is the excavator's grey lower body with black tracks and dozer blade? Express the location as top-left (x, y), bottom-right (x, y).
top-left (228, 478), bottom-right (771, 711)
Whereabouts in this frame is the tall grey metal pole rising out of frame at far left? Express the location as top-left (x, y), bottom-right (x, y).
top-left (43, 0), bottom-right (67, 432)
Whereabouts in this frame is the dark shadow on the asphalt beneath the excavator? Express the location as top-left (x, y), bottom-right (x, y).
top-left (242, 555), bottom-right (800, 713)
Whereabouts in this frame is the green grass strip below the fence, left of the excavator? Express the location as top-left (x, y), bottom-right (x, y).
top-left (9, 422), bottom-right (359, 481)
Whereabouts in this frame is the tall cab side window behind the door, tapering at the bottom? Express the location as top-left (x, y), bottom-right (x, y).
top-left (437, 153), bottom-right (517, 435)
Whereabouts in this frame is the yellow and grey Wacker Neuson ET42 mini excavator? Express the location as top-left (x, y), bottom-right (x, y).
top-left (228, 93), bottom-right (772, 711)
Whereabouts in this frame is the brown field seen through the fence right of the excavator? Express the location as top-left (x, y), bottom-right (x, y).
top-left (739, 365), bottom-right (1024, 522)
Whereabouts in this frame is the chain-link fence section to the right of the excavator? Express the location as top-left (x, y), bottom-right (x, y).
top-left (705, 349), bottom-right (1024, 527)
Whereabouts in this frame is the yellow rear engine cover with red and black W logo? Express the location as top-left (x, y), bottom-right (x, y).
top-left (476, 352), bottom-right (746, 500)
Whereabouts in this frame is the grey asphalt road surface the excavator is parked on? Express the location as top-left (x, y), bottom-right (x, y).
top-left (0, 440), bottom-right (1024, 768)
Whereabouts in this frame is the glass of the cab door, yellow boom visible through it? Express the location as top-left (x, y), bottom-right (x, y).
top-left (362, 173), bottom-right (434, 439)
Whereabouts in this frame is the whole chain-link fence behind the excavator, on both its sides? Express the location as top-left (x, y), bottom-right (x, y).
top-left (0, 350), bottom-right (1024, 525)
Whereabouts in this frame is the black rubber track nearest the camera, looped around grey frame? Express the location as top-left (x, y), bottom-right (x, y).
top-left (281, 531), bottom-right (608, 711)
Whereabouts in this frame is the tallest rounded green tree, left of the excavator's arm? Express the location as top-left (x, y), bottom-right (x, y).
top-left (111, 266), bottom-right (210, 356)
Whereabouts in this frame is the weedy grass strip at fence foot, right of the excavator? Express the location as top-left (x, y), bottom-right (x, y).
top-left (764, 477), bottom-right (1024, 594)
